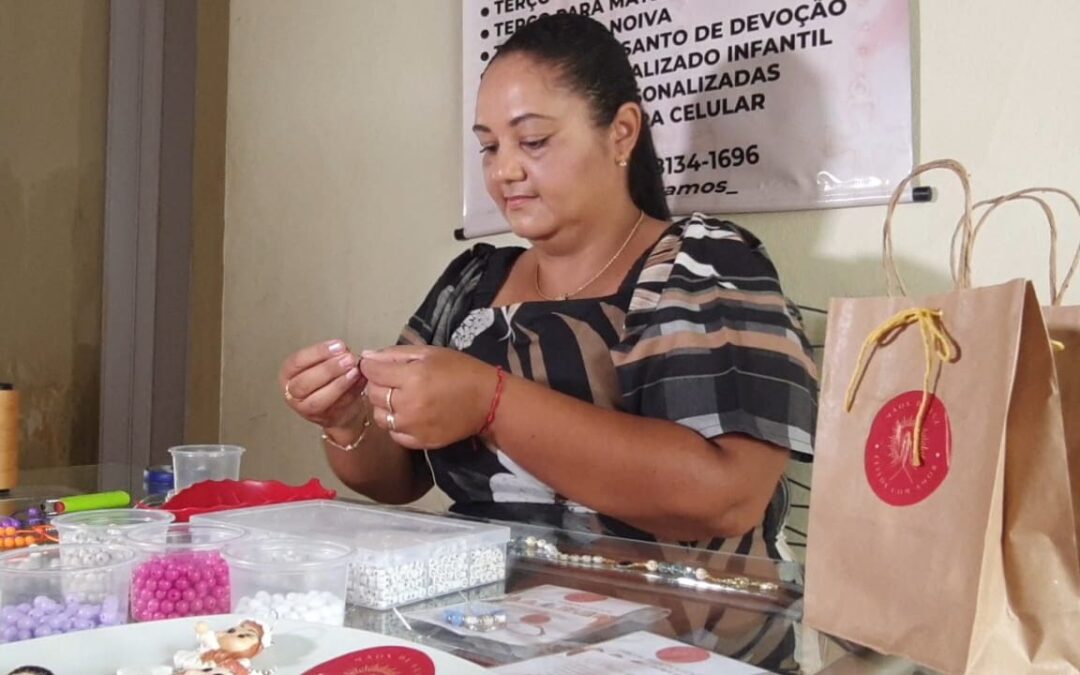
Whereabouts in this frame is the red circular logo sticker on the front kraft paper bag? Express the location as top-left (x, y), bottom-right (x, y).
top-left (866, 391), bottom-right (953, 507)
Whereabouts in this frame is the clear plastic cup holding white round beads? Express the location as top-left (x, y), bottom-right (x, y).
top-left (222, 538), bottom-right (352, 625)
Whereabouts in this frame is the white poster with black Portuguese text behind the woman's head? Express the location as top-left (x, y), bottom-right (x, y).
top-left (462, 0), bottom-right (913, 237)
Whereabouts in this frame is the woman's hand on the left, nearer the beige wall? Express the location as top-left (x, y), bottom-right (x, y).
top-left (278, 340), bottom-right (367, 430)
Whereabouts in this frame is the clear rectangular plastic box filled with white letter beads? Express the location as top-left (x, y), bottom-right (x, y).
top-left (191, 500), bottom-right (510, 609)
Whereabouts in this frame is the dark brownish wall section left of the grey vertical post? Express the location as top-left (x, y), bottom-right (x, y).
top-left (0, 0), bottom-right (109, 468)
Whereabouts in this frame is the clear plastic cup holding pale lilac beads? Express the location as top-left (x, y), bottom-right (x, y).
top-left (0, 544), bottom-right (135, 643)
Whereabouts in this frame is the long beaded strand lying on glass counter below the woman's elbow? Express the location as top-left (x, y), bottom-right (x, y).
top-left (513, 537), bottom-right (780, 599)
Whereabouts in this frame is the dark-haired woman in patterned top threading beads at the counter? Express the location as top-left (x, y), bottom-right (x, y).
top-left (280, 14), bottom-right (816, 557)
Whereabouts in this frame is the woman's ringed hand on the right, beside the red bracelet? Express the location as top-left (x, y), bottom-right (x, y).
top-left (360, 346), bottom-right (498, 449)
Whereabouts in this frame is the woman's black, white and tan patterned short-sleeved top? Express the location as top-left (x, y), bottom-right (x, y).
top-left (400, 214), bottom-right (818, 558)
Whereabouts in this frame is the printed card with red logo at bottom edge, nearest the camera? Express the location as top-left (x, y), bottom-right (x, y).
top-left (491, 631), bottom-right (769, 675)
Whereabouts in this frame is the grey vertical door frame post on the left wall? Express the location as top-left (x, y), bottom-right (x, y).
top-left (98, 0), bottom-right (197, 495)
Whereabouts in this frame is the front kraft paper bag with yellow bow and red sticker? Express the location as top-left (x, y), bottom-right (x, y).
top-left (806, 160), bottom-right (1080, 674)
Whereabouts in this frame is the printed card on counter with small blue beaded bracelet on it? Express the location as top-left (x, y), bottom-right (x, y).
top-left (406, 585), bottom-right (667, 647)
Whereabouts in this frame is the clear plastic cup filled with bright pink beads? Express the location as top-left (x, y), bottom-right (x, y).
top-left (125, 523), bottom-right (247, 621)
